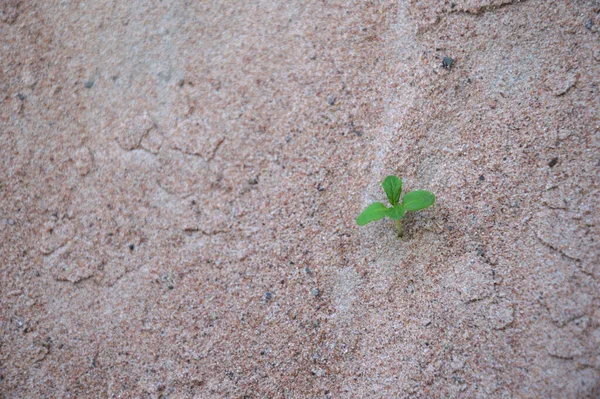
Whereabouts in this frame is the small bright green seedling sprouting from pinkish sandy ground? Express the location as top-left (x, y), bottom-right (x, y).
top-left (356, 176), bottom-right (435, 237)
